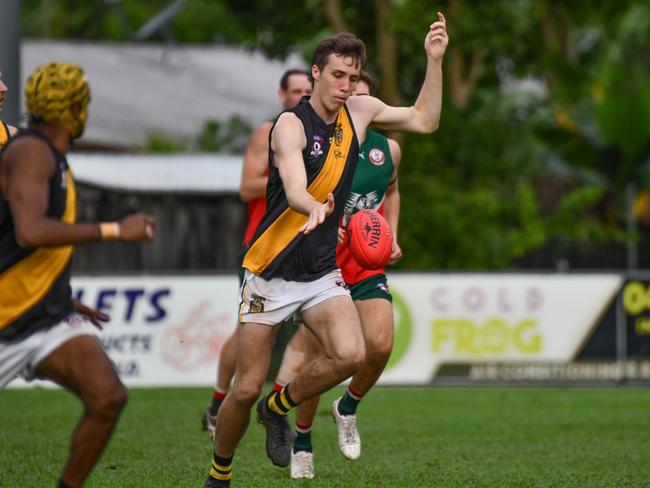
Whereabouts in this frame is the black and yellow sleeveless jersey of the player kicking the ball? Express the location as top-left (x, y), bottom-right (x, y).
top-left (243, 97), bottom-right (359, 281)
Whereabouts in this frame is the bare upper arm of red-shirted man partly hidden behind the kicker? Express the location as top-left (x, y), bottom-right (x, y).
top-left (239, 122), bottom-right (273, 202)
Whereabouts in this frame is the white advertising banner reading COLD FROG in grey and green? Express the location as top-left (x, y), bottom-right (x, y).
top-left (380, 274), bottom-right (623, 384)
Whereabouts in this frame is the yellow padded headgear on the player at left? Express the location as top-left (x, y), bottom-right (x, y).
top-left (25, 61), bottom-right (90, 139)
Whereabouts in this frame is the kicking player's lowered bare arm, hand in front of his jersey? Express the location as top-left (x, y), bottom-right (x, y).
top-left (271, 113), bottom-right (334, 234)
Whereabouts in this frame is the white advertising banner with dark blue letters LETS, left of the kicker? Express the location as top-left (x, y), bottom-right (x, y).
top-left (12, 275), bottom-right (238, 386)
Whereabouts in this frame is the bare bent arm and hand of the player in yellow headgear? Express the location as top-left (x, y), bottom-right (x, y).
top-left (0, 138), bottom-right (155, 247)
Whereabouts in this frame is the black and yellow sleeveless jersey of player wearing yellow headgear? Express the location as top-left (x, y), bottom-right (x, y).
top-left (0, 130), bottom-right (76, 342)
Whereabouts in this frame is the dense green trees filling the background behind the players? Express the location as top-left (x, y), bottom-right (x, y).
top-left (23, 0), bottom-right (650, 269)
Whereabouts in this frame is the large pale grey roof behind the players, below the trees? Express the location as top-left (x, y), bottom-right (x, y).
top-left (21, 40), bottom-right (304, 145)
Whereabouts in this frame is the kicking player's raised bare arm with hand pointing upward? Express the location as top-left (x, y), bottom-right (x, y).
top-left (348, 12), bottom-right (448, 134)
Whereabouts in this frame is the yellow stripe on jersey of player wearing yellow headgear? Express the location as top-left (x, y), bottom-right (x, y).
top-left (0, 169), bottom-right (77, 329)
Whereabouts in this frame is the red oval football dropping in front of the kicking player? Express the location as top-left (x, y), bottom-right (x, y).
top-left (347, 210), bottom-right (393, 269)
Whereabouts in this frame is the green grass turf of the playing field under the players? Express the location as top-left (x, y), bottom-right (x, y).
top-left (0, 388), bottom-right (650, 488)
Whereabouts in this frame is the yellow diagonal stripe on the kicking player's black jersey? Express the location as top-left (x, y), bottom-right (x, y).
top-left (243, 106), bottom-right (354, 275)
